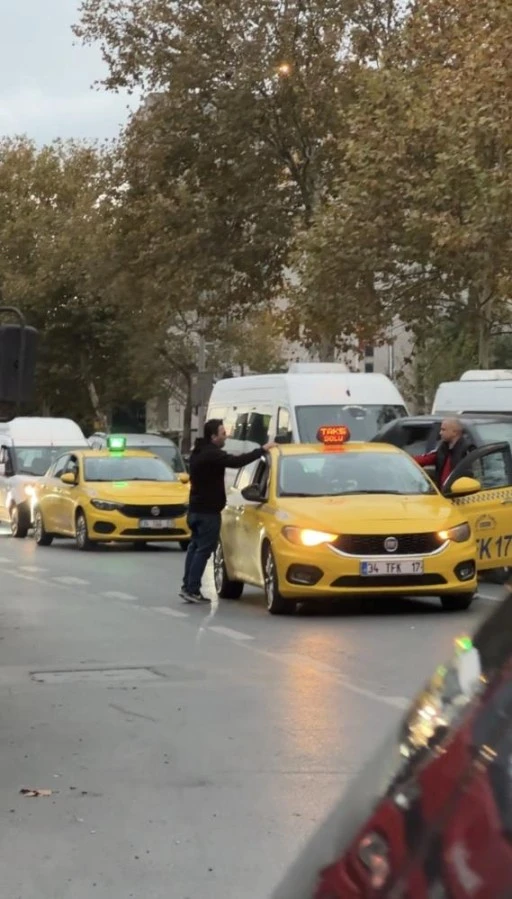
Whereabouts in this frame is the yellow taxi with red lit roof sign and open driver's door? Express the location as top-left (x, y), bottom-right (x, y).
top-left (214, 426), bottom-right (512, 614)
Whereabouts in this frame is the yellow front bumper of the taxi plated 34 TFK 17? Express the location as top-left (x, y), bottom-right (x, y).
top-left (273, 537), bottom-right (477, 599)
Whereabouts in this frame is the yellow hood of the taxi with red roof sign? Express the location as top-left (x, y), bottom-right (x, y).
top-left (278, 494), bottom-right (464, 534)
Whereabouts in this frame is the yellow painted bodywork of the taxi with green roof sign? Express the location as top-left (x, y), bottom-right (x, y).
top-left (34, 449), bottom-right (190, 543)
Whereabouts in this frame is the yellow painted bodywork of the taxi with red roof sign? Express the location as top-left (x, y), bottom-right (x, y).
top-left (221, 443), bottom-right (512, 600)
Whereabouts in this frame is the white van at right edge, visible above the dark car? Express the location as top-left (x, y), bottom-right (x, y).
top-left (432, 370), bottom-right (512, 416)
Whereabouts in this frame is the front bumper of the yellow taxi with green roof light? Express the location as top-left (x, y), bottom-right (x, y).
top-left (86, 506), bottom-right (191, 543)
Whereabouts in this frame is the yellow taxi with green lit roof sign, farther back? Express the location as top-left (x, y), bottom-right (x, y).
top-left (33, 437), bottom-right (190, 550)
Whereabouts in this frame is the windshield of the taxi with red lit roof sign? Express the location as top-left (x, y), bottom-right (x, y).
top-left (278, 451), bottom-right (437, 497)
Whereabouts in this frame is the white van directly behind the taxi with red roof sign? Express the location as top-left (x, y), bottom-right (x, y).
top-left (208, 364), bottom-right (407, 452)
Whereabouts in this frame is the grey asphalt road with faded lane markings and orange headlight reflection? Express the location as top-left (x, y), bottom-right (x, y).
top-left (0, 535), bottom-right (500, 899)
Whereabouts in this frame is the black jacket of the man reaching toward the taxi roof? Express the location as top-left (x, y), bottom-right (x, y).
top-left (189, 440), bottom-right (263, 513)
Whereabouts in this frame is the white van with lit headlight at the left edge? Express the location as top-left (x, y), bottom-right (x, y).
top-left (0, 416), bottom-right (88, 537)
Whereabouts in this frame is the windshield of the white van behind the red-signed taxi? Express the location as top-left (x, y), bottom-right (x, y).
top-left (295, 403), bottom-right (407, 443)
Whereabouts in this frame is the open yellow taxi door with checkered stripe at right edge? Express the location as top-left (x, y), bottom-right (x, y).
top-left (443, 443), bottom-right (512, 571)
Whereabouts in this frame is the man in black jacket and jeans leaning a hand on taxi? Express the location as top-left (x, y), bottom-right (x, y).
top-left (180, 418), bottom-right (275, 603)
